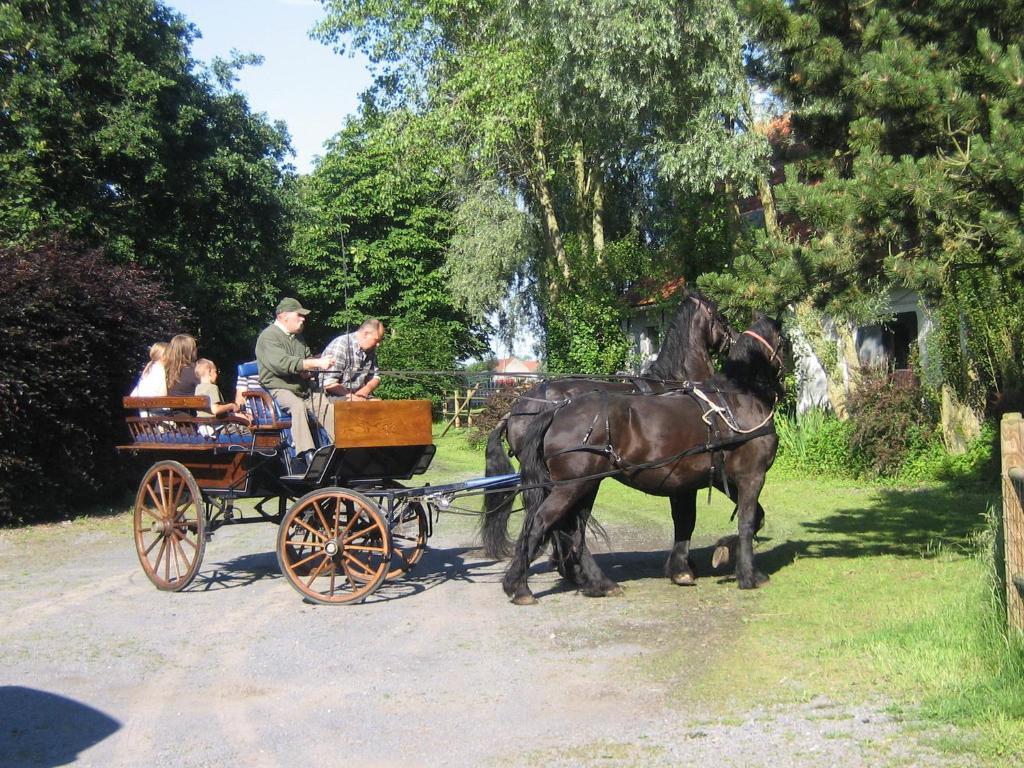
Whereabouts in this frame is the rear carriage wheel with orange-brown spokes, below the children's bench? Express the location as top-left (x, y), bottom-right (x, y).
top-left (134, 461), bottom-right (206, 592)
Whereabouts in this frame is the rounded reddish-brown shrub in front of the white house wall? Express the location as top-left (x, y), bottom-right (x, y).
top-left (848, 368), bottom-right (937, 477)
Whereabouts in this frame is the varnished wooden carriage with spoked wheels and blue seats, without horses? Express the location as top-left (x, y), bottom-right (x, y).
top-left (118, 364), bottom-right (515, 604)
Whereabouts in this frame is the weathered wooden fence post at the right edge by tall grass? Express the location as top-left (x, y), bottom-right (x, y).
top-left (999, 414), bottom-right (1024, 633)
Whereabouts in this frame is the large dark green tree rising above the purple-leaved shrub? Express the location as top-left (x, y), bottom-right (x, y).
top-left (0, 0), bottom-right (296, 370)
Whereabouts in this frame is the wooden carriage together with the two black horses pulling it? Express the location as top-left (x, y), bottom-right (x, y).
top-left (120, 295), bottom-right (783, 603)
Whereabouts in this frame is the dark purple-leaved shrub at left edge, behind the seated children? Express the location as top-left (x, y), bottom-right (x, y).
top-left (0, 240), bottom-right (182, 525)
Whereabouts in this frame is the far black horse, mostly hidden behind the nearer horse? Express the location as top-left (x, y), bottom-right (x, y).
top-left (480, 292), bottom-right (745, 585)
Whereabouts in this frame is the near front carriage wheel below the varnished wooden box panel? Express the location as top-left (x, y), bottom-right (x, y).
top-left (278, 488), bottom-right (392, 605)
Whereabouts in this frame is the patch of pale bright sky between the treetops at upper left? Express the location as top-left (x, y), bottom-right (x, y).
top-left (165, 0), bottom-right (371, 173)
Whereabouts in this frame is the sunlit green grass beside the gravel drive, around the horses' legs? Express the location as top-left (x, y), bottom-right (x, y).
top-left (438, 435), bottom-right (1024, 766)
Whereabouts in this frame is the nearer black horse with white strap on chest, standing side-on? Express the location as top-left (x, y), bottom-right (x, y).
top-left (503, 316), bottom-right (783, 604)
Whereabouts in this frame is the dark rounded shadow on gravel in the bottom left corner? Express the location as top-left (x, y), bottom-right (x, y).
top-left (0, 685), bottom-right (121, 766)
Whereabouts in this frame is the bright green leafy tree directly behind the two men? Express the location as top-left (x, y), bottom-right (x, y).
top-left (284, 110), bottom-right (486, 396)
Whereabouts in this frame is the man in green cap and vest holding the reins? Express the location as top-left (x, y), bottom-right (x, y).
top-left (256, 297), bottom-right (334, 464)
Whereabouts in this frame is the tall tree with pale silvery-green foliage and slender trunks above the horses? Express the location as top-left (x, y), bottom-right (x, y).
top-left (319, 0), bottom-right (765, 360)
